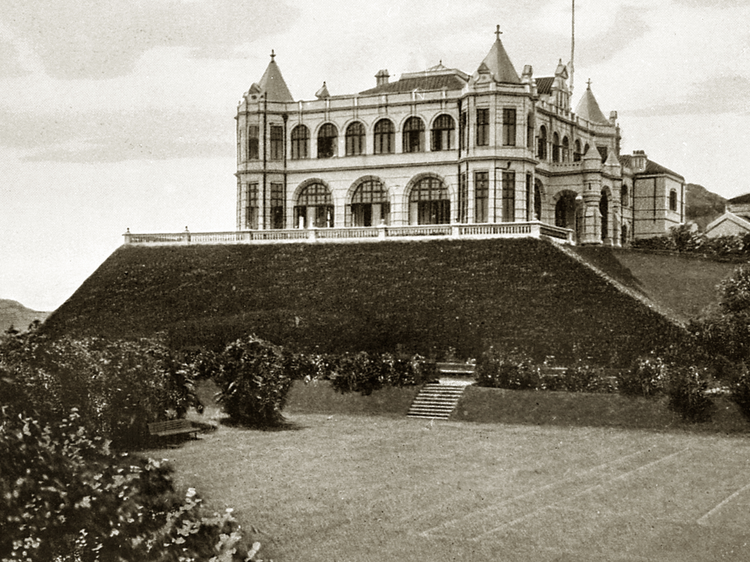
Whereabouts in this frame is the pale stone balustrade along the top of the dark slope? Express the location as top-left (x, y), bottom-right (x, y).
top-left (123, 221), bottom-right (574, 245)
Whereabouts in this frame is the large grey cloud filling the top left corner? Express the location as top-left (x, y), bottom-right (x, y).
top-left (0, 0), bottom-right (298, 79)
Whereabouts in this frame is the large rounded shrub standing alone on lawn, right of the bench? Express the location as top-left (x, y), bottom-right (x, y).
top-left (215, 336), bottom-right (295, 427)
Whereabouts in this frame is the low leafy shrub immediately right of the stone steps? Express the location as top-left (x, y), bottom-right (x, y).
top-left (476, 347), bottom-right (541, 390)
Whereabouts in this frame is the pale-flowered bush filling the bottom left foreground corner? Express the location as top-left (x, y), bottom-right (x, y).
top-left (0, 408), bottom-right (259, 562)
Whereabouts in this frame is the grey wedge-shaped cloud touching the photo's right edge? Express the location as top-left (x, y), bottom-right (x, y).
top-left (623, 74), bottom-right (750, 117)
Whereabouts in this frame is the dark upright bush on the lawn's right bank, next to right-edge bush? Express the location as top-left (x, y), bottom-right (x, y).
top-left (667, 365), bottom-right (714, 423)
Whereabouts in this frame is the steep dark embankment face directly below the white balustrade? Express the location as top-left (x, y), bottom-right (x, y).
top-left (45, 239), bottom-right (678, 362)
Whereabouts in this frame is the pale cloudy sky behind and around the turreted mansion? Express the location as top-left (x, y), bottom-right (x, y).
top-left (0, 0), bottom-right (750, 311)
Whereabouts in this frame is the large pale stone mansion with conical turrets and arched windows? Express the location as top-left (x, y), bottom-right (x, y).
top-left (236, 33), bottom-right (685, 246)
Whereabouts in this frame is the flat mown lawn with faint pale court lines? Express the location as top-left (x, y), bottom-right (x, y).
top-left (148, 408), bottom-right (750, 562)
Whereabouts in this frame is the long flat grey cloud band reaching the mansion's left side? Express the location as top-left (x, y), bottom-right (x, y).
top-left (0, 105), bottom-right (235, 163)
